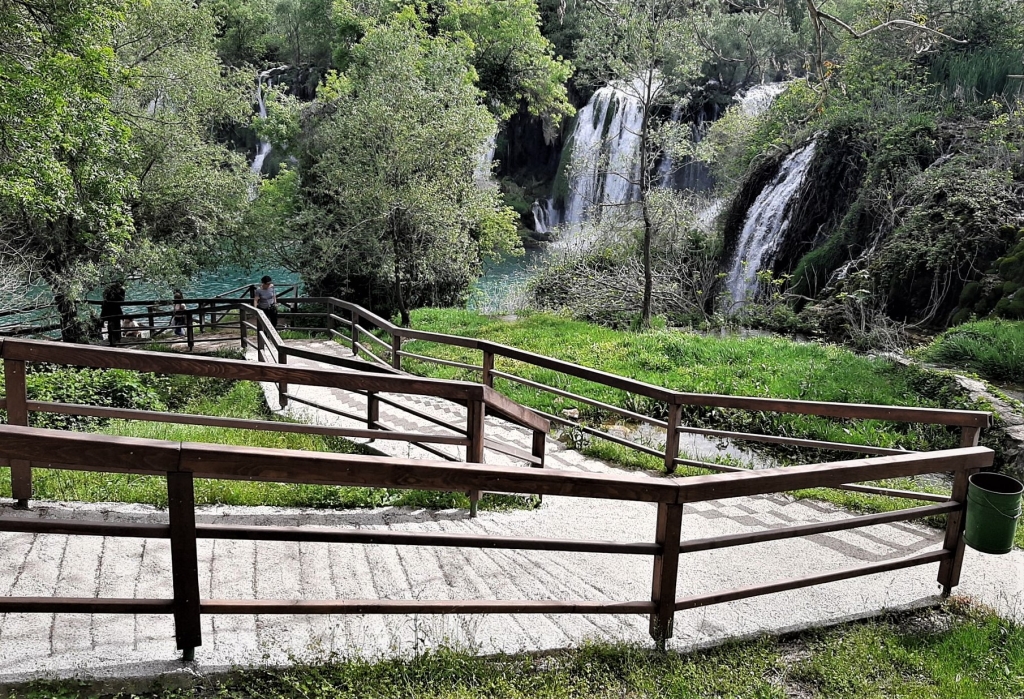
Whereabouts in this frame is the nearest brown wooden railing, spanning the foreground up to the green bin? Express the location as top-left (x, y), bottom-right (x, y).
top-left (0, 421), bottom-right (992, 659)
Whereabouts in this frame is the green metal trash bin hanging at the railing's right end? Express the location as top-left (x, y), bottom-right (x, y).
top-left (964, 472), bottom-right (1024, 554)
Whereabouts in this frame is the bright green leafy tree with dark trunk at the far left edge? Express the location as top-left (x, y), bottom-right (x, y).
top-left (0, 0), bottom-right (137, 340)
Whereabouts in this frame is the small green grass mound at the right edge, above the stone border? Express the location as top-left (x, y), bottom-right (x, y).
top-left (920, 320), bottom-right (1024, 382)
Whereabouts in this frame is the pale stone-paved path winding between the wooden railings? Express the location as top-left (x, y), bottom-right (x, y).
top-left (0, 341), bottom-right (1024, 682)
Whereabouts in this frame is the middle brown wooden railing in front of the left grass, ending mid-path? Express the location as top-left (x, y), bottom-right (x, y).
top-left (0, 335), bottom-right (550, 516)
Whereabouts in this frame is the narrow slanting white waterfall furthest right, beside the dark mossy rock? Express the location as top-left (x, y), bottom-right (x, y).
top-left (726, 141), bottom-right (816, 307)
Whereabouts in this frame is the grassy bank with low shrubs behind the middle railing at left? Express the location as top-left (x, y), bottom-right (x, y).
top-left (0, 358), bottom-right (512, 509)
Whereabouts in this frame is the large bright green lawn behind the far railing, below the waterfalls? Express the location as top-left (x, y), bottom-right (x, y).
top-left (395, 309), bottom-right (976, 457)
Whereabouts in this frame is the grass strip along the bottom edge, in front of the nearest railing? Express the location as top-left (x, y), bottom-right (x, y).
top-left (25, 601), bottom-right (1024, 699)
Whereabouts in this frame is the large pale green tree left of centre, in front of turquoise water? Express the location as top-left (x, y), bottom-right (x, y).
top-left (294, 18), bottom-right (518, 325)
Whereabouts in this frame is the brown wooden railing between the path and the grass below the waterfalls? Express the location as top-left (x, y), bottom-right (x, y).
top-left (258, 298), bottom-right (991, 501)
